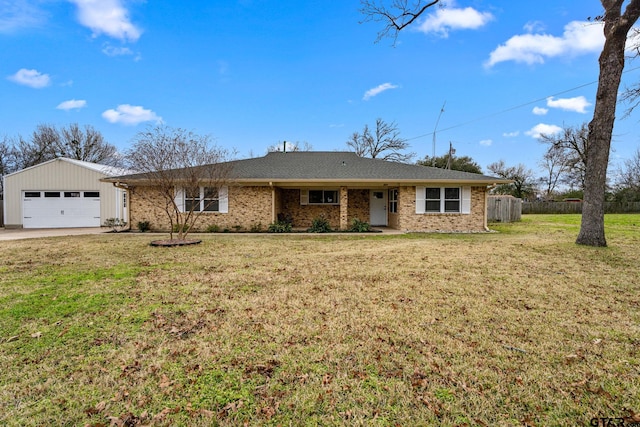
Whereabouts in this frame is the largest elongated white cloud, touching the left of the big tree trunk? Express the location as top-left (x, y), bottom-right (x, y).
top-left (485, 21), bottom-right (604, 67)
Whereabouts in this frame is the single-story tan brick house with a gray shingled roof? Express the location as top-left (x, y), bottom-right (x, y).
top-left (102, 151), bottom-right (510, 232)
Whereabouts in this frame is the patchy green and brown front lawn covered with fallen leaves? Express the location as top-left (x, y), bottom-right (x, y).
top-left (0, 215), bottom-right (640, 426)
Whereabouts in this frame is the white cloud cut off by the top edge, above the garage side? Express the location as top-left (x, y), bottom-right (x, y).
top-left (69, 0), bottom-right (142, 41)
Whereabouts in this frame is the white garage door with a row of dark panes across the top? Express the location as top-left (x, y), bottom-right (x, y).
top-left (22, 191), bottom-right (100, 228)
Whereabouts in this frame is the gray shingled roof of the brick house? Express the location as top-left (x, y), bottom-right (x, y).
top-left (108, 151), bottom-right (510, 184)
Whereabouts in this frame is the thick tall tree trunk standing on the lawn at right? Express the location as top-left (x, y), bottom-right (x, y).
top-left (576, 0), bottom-right (640, 246)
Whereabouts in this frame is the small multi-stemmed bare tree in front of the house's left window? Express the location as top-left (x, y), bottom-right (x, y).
top-left (125, 125), bottom-right (230, 240)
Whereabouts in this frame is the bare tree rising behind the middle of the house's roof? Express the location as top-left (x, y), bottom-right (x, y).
top-left (346, 119), bottom-right (415, 163)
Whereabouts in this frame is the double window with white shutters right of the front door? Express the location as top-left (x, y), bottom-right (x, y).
top-left (416, 187), bottom-right (471, 214)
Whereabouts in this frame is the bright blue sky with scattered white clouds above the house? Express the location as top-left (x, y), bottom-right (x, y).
top-left (0, 0), bottom-right (640, 177)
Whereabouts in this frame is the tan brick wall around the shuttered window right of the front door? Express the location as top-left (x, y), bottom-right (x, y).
top-left (398, 187), bottom-right (487, 231)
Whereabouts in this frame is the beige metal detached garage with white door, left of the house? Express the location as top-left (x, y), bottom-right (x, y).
top-left (4, 157), bottom-right (127, 228)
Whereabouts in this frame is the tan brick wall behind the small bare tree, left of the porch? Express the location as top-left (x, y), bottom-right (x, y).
top-left (129, 187), bottom-right (273, 231)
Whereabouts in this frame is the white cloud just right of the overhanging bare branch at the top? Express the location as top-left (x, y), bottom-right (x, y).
top-left (418, 2), bottom-right (493, 37)
